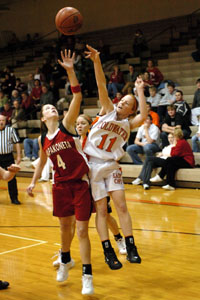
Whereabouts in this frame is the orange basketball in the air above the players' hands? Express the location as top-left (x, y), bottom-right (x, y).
top-left (55, 7), bottom-right (83, 35)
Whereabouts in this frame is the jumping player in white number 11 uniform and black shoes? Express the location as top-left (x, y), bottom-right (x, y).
top-left (84, 45), bottom-right (147, 269)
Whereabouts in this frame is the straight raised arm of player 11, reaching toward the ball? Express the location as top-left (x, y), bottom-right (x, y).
top-left (85, 45), bottom-right (114, 114)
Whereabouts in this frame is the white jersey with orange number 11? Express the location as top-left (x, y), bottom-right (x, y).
top-left (84, 108), bottom-right (130, 161)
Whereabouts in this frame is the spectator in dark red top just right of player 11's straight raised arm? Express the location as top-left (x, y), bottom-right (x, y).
top-left (108, 65), bottom-right (124, 97)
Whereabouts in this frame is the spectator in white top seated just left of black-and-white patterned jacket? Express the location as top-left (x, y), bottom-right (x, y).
top-left (157, 83), bottom-right (176, 122)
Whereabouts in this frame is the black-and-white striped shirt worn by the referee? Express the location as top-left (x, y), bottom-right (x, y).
top-left (0, 126), bottom-right (20, 155)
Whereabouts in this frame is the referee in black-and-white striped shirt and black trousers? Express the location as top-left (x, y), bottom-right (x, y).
top-left (0, 115), bottom-right (21, 204)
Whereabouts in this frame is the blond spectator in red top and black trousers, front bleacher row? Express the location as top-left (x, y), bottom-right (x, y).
top-left (150, 128), bottom-right (195, 191)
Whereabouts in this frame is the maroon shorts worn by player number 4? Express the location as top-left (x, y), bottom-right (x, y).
top-left (52, 180), bottom-right (92, 221)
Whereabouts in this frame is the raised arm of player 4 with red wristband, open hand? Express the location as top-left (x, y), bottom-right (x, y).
top-left (58, 50), bottom-right (82, 134)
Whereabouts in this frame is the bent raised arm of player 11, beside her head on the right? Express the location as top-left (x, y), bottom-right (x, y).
top-left (130, 77), bottom-right (147, 129)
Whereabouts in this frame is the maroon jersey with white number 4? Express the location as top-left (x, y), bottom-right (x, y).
top-left (41, 124), bottom-right (89, 183)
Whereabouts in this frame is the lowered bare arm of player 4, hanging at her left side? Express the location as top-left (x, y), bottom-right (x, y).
top-left (26, 136), bottom-right (47, 197)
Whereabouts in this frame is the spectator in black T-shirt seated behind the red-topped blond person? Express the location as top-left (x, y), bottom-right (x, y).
top-left (160, 104), bottom-right (191, 148)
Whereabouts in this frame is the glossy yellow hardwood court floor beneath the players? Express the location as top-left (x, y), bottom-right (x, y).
top-left (0, 177), bottom-right (200, 300)
